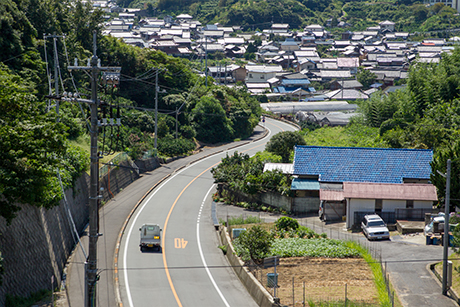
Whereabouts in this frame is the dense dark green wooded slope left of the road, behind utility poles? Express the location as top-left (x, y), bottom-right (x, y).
top-left (0, 0), bottom-right (261, 223)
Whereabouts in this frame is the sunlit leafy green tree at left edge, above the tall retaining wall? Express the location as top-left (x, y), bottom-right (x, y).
top-left (0, 67), bottom-right (85, 223)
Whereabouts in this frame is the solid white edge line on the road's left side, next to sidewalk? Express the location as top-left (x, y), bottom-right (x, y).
top-left (123, 124), bottom-right (271, 307)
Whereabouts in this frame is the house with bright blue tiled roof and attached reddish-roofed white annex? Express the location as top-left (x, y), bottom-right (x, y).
top-left (291, 146), bottom-right (437, 228)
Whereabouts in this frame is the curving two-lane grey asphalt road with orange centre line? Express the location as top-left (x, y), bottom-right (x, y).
top-left (118, 119), bottom-right (295, 307)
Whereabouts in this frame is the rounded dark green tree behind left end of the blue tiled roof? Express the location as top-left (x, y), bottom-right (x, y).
top-left (265, 131), bottom-right (307, 163)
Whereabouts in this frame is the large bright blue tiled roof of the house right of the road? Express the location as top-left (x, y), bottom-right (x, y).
top-left (294, 146), bottom-right (433, 183)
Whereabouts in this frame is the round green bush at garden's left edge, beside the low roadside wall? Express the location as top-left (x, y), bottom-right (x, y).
top-left (235, 225), bottom-right (274, 263)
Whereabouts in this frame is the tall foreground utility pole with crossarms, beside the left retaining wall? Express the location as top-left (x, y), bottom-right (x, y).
top-left (68, 31), bottom-right (121, 307)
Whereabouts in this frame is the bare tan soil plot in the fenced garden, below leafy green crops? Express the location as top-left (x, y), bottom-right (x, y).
top-left (257, 257), bottom-right (378, 306)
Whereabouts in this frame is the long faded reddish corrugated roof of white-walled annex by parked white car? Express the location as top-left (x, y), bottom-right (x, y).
top-left (343, 182), bottom-right (438, 201)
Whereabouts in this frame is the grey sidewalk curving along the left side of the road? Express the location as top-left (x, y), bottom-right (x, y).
top-left (58, 126), bottom-right (265, 307)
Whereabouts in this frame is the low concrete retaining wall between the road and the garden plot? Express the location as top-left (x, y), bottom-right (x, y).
top-left (219, 226), bottom-right (278, 307)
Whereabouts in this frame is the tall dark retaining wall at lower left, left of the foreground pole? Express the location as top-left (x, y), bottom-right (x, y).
top-left (0, 175), bottom-right (89, 306)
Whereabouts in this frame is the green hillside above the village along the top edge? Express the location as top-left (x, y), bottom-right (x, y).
top-left (118, 0), bottom-right (460, 35)
